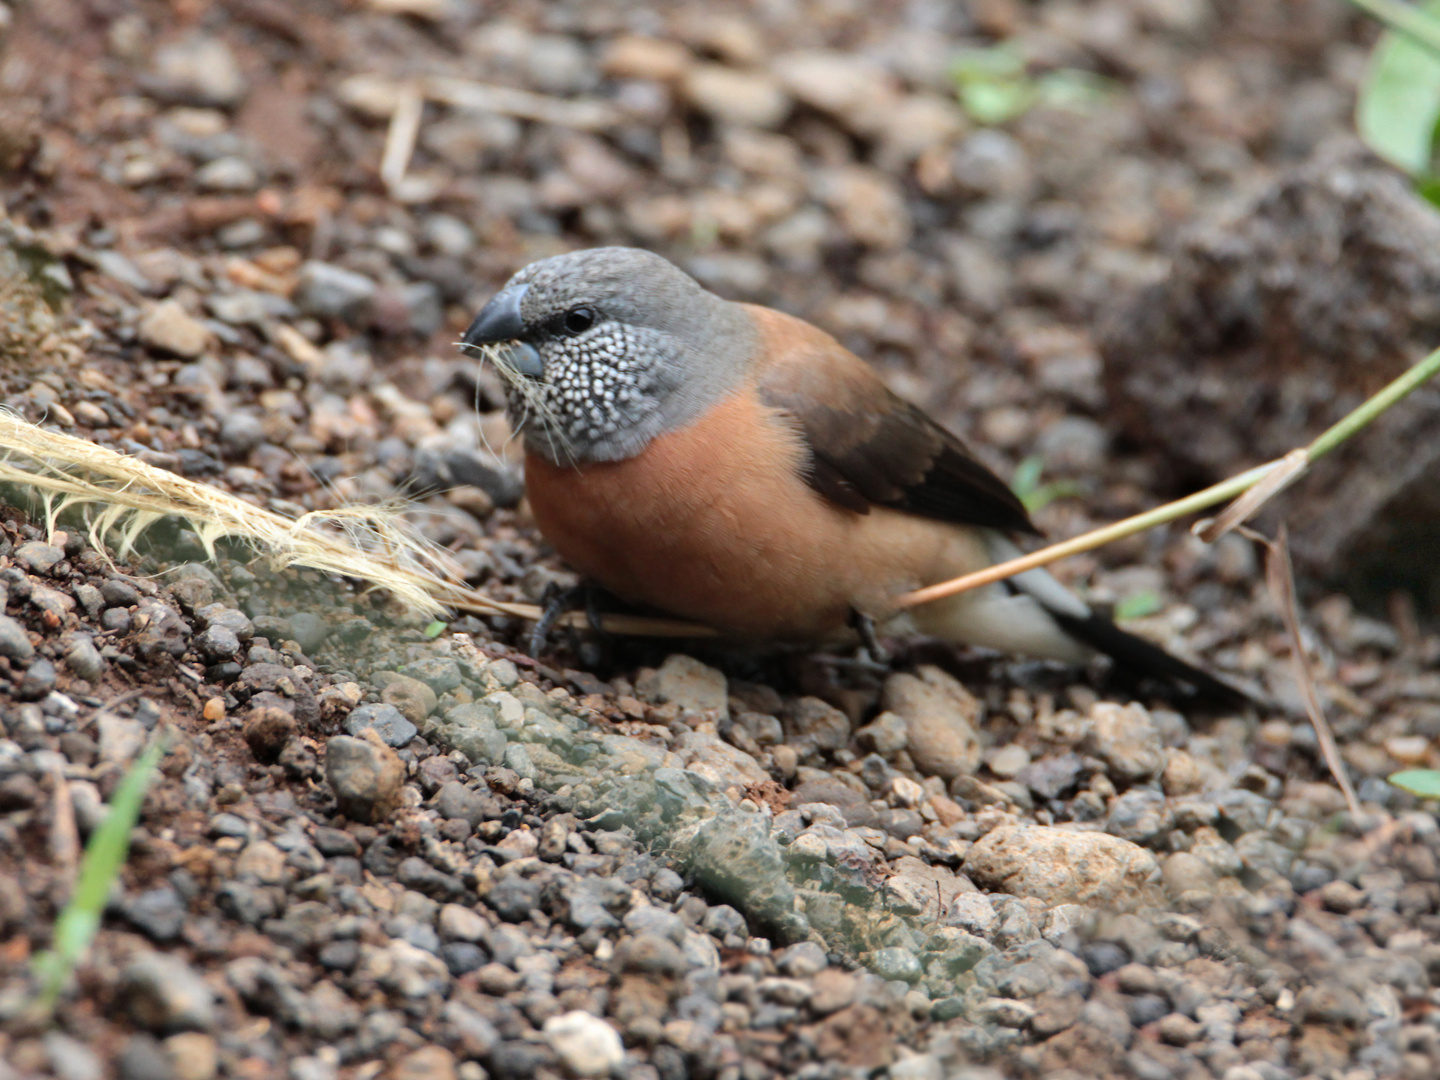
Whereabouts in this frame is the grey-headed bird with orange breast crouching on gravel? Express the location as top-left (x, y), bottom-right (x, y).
top-left (461, 248), bottom-right (1238, 701)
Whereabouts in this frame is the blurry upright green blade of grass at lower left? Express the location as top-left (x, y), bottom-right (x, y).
top-left (35, 739), bottom-right (164, 1015)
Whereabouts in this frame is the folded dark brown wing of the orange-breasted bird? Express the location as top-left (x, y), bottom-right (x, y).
top-left (752, 308), bottom-right (1040, 533)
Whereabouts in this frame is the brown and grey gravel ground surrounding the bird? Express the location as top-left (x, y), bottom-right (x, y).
top-left (0, 0), bottom-right (1440, 1080)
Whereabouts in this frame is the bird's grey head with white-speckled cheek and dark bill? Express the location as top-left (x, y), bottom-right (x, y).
top-left (461, 248), bottom-right (756, 464)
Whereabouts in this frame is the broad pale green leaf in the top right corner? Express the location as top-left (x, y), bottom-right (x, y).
top-left (1355, 0), bottom-right (1440, 177)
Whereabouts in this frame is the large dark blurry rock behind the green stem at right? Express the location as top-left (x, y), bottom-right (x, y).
top-left (1100, 151), bottom-right (1440, 609)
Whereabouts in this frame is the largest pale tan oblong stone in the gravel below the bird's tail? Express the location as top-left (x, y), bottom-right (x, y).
top-left (965, 825), bottom-right (1159, 909)
